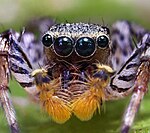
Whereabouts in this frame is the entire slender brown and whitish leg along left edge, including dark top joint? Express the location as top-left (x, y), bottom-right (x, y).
top-left (0, 31), bottom-right (19, 133)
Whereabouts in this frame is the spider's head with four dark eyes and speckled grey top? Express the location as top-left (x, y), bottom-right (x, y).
top-left (42, 23), bottom-right (110, 63)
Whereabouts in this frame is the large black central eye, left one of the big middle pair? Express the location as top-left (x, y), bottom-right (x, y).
top-left (54, 36), bottom-right (74, 56)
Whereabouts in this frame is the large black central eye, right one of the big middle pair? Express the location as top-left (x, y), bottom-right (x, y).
top-left (76, 37), bottom-right (96, 57)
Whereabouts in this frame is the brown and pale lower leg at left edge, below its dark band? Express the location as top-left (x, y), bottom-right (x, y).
top-left (0, 55), bottom-right (19, 133)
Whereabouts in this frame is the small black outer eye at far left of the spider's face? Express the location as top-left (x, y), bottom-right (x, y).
top-left (42, 34), bottom-right (53, 47)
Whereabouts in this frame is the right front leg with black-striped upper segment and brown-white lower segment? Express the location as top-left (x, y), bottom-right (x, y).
top-left (106, 34), bottom-right (150, 133)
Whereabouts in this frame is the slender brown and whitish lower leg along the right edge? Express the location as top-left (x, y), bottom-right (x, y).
top-left (121, 36), bottom-right (150, 133)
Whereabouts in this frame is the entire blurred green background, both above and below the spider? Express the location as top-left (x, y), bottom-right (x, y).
top-left (0, 0), bottom-right (150, 133)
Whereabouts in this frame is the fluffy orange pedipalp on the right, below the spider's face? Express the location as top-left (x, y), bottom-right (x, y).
top-left (71, 78), bottom-right (108, 121)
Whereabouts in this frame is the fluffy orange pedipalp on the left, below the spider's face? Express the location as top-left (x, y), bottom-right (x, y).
top-left (39, 83), bottom-right (71, 123)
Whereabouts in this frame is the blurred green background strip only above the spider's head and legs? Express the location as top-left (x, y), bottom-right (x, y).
top-left (0, 0), bottom-right (150, 29)
